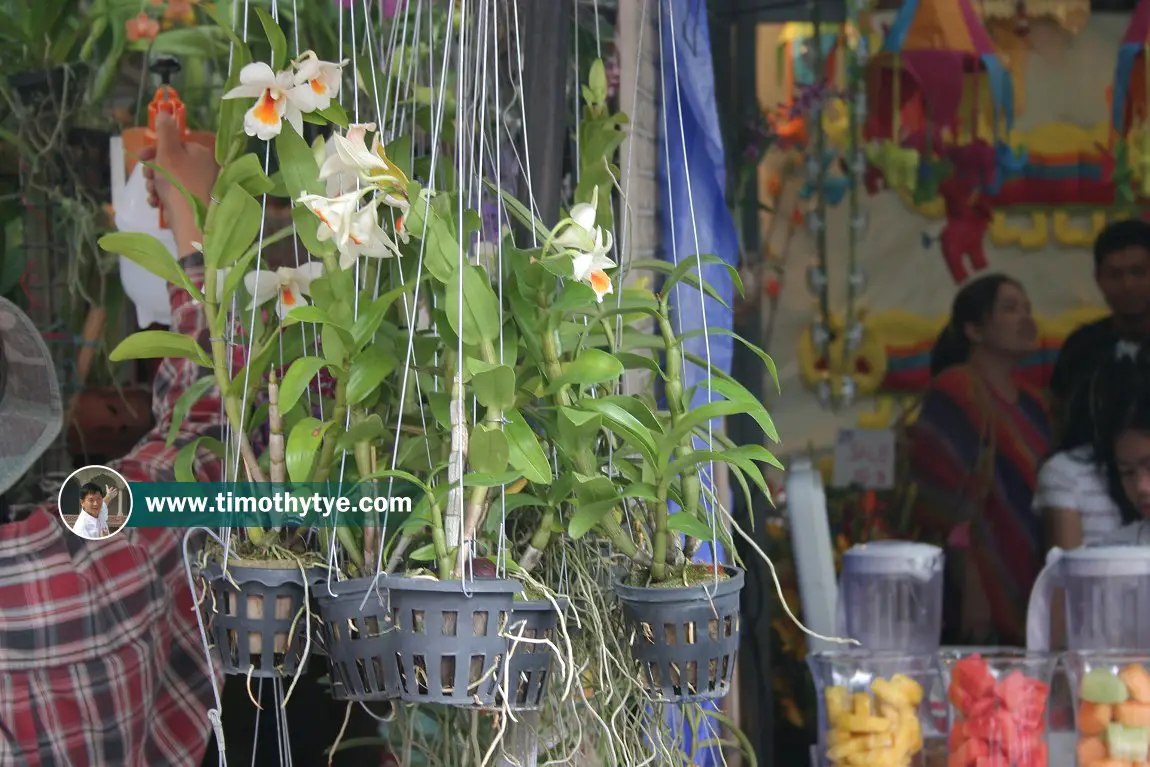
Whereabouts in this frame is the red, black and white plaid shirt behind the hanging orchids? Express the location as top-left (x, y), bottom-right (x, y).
top-left (0, 254), bottom-right (222, 767)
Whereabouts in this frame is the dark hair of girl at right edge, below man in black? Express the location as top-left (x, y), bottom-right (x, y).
top-left (1094, 348), bottom-right (1150, 524)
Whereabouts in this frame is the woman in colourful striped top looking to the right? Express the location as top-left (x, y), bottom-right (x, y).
top-left (909, 275), bottom-right (1051, 646)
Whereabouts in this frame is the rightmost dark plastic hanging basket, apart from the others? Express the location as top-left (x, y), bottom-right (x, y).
top-left (615, 567), bottom-right (743, 703)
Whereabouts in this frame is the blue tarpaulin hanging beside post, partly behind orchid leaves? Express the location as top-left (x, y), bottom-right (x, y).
top-left (658, 0), bottom-right (738, 767)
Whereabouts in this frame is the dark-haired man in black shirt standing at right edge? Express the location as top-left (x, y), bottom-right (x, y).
top-left (1050, 218), bottom-right (1150, 428)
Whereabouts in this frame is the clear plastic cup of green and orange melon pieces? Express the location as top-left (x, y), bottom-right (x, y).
top-left (1063, 650), bottom-right (1150, 767)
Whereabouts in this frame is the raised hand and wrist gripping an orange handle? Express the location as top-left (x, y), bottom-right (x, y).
top-left (139, 112), bottom-right (220, 255)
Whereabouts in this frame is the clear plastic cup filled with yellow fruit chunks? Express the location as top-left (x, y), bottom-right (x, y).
top-left (807, 650), bottom-right (937, 767)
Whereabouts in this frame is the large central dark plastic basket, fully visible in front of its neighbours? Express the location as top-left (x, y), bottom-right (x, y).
top-left (388, 577), bottom-right (522, 707)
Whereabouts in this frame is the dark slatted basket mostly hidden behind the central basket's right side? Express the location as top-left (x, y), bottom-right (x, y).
top-left (506, 599), bottom-right (570, 710)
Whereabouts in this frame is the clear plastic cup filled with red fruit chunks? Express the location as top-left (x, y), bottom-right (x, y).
top-left (938, 647), bottom-right (1058, 767)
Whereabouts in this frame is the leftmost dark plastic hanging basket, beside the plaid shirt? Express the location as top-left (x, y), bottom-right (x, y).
top-left (201, 562), bottom-right (316, 678)
